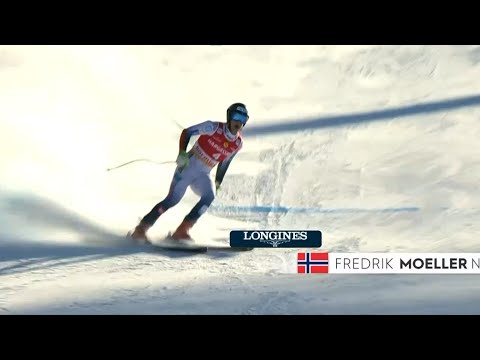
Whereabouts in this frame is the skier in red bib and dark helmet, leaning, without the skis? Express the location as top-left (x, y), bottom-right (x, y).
top-left (130, 103), bottom-right (249, 242)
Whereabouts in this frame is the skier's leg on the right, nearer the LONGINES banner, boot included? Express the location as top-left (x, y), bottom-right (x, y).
top-left (172, 174), bottom-right (215, 239)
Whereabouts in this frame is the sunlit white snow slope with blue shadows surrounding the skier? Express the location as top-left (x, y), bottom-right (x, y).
top-left (0, 45), bottom-right (480, 314)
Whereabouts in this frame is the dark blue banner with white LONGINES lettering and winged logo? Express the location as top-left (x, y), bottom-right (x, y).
top-left (230, 230), bottom-right (322, 248)
